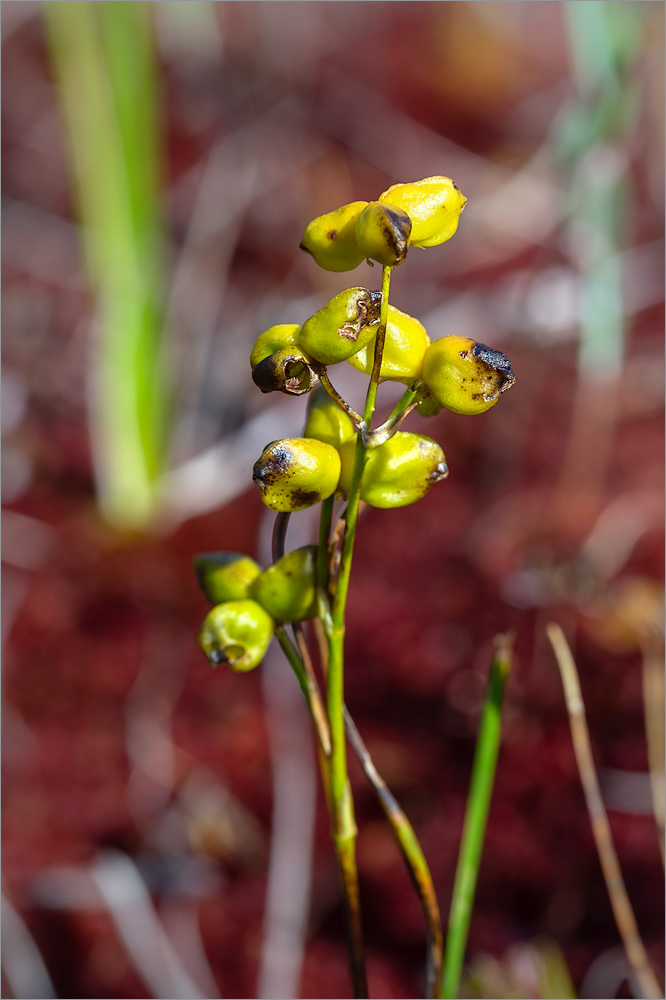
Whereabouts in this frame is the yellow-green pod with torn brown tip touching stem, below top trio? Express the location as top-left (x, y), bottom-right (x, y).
top-left (299, 288), bottom-right (382, 365)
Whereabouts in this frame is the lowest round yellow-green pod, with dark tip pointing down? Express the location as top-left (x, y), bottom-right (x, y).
top-left (199, 600), bottom-right (273, 671)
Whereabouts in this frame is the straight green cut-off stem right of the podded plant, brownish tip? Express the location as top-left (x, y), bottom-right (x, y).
top-left (440, 635), bottom-right (513, 998)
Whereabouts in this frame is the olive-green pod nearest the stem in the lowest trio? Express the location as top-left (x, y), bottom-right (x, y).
top-left (252, 545), bottom-right (317, 622)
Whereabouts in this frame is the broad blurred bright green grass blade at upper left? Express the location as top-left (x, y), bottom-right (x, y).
top-left (42, 0), bottom-right (168, 528)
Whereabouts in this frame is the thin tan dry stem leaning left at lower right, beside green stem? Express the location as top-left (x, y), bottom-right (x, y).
top-left (546, 623), bottom-right (663, 1000)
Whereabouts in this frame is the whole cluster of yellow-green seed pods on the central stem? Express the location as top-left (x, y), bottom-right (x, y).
top-left (195, 177), bottom-right (515, 671)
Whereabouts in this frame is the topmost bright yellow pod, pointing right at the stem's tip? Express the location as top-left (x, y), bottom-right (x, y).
top-left (379, 177), bottom-right (467, 247)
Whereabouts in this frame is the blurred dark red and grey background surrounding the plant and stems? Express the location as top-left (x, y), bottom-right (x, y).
top-left (2, 0), bottom-right (664, 998)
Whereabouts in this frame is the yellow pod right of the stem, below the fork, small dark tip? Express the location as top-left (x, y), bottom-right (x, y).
top-left (339, 431), bottom-right (449, 508)
